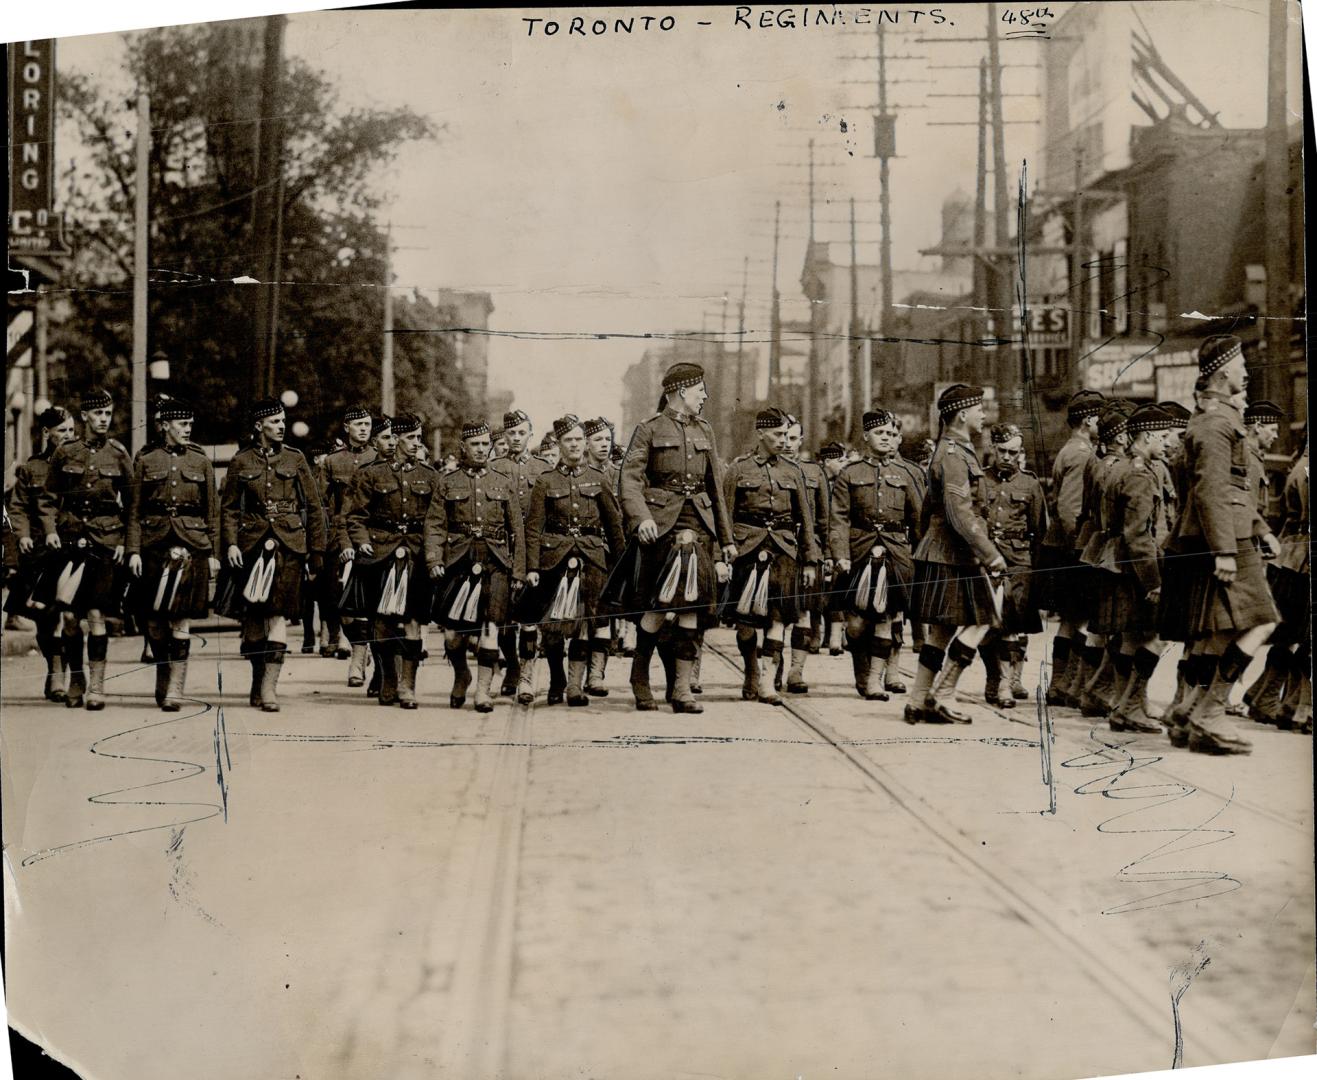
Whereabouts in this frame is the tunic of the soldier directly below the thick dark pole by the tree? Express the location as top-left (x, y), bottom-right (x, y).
top-left (220, 444), bottom-right (329, 554)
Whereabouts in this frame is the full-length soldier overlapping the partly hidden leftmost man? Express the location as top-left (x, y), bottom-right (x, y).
top-left (33, 390), bottom-right (133, 710)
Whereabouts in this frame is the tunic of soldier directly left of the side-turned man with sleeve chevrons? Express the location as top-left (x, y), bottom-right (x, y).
top-left (828, 457), bottom-right (923, 562)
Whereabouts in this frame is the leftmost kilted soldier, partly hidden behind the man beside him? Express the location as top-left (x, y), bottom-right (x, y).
top-left (5, 406), bottom-right (74, 702)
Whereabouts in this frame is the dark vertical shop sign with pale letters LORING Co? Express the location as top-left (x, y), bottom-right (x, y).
top-left (8, 41), bottom-right (72, 257)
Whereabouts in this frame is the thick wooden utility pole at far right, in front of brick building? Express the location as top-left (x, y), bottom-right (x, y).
top-left (1260, 0), bottom-right (1293, 450)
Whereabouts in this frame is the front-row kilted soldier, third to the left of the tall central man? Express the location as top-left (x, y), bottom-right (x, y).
top-left (340, 414), bottom-right (440, 709)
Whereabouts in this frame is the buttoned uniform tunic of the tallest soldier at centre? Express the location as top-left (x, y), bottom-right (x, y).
top-left (619, 408), bottom-right (735, 547)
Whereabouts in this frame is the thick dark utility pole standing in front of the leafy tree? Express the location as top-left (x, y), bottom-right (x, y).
top-left (252, 14), bottom-right (287, 398)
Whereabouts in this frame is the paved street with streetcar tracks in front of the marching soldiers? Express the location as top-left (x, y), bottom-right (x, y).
top-left (3, 632), bottom-right (1314, 1080)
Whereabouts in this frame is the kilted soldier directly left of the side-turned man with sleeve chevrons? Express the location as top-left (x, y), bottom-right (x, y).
top-left (828, 410), bottom-right (923, 701)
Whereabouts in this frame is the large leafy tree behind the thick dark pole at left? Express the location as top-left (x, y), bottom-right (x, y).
top-left (51, 20), bottom-right (461, 443)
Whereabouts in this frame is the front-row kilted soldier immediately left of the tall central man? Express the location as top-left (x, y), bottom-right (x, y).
top-left (525, 416), bottom-right (626, 706)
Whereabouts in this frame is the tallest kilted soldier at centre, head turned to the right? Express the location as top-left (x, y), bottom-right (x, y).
top-left (612, 364), bottom-right (736, 713)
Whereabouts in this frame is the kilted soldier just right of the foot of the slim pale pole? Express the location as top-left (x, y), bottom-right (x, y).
top-left (125, 399), bottom-right (220, 713)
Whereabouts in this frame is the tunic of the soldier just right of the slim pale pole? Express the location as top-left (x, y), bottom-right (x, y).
top-left (126, 446), bottom-right (220, 556)
